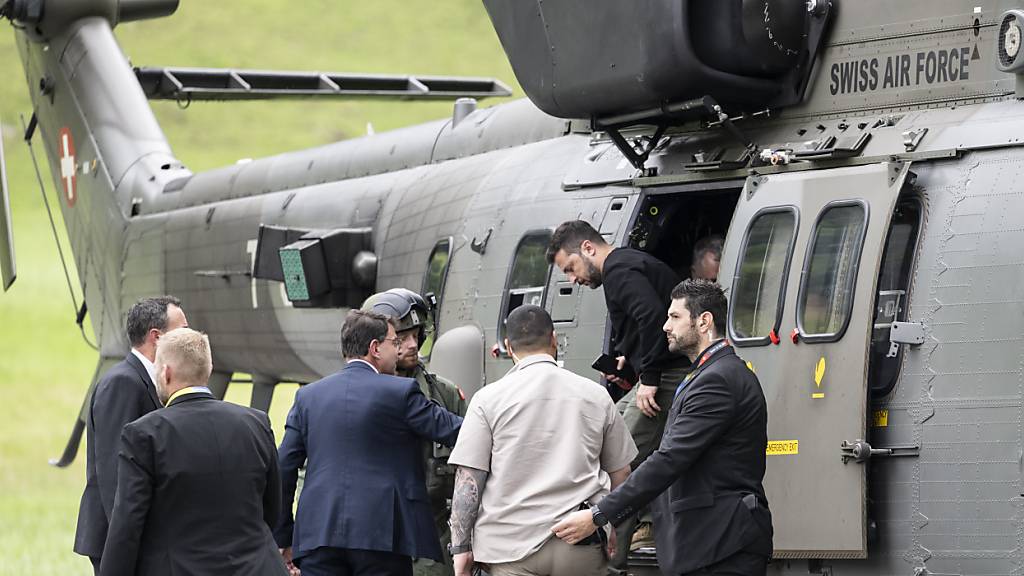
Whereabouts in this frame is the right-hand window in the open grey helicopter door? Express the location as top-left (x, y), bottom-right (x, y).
top-left (797, 202), bottom-right (867, 342)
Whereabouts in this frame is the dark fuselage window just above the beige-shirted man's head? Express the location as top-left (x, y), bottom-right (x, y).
top-left (498, 230), bottom-right (551, 354)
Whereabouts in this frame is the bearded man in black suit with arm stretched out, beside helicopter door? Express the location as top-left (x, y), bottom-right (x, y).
top-left (552, 280), bottom-right (772, 576)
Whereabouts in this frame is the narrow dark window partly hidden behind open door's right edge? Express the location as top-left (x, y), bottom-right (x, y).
top-left (867, 198), bottom-right (924, 398)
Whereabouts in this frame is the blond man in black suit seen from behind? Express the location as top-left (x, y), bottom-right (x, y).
top-left (99, 328), bottom-right (288, 576)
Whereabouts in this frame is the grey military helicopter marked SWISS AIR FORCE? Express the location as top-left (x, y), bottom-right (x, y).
top-left (6, 0), bottom-right (1024, 575)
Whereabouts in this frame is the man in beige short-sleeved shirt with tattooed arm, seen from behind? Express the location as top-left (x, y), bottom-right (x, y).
top-left (449, 304), bottom-right (637, 576)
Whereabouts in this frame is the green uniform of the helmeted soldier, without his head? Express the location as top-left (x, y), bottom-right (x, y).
top-left (412, 363), bottom-right (466, 576)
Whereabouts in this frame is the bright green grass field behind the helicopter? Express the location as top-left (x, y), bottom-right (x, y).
top-left (0, 0), bottom-right (515, 575)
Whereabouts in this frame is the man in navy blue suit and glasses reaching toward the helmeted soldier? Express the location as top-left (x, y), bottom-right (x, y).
top-left (275, 311), bottom-right (462, 576)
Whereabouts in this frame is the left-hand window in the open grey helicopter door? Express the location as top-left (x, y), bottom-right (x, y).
top-left (729, 207), bottom-right (797, 345)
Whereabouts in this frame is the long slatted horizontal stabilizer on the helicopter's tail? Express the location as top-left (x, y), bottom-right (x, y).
top-left (135, 67), bottom-right (512, 102)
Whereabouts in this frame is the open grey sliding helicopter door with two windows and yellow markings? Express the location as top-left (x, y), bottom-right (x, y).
top-left (720, 163), bottom-right (907, 559)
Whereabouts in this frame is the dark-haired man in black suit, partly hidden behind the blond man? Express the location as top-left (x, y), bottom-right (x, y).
top-left (75, 296), bottom-right (188, 573)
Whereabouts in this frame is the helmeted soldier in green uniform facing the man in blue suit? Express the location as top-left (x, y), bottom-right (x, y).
top-left (362, 288), bottom-right (466, 576)
